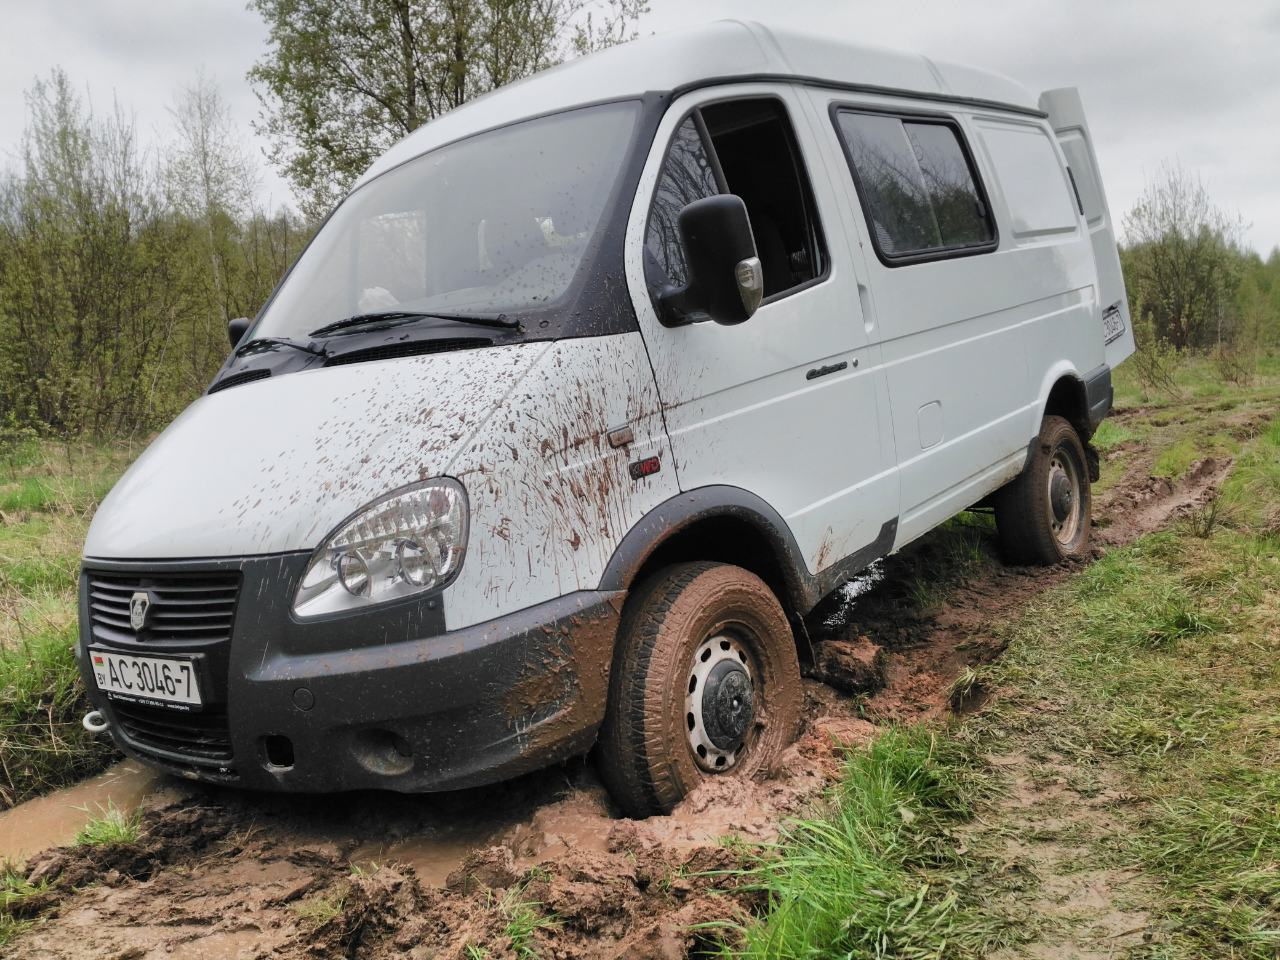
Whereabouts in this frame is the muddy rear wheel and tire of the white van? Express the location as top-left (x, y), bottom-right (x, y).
top-left (996, 416), bottom-right (1093, 566)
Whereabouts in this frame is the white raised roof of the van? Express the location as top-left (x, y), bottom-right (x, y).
top-left (357, 20), bottom-right (1039, 186)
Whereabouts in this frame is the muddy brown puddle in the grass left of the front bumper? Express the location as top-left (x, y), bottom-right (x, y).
top-left (0, 760), bottom-right (165, 863)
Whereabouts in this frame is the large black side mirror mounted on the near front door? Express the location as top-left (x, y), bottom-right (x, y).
top-left (662, 193), bottom-right (764, 326)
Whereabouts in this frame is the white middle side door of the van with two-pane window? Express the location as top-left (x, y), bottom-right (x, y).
top-left (814, 101), bottom-right (1033, 545)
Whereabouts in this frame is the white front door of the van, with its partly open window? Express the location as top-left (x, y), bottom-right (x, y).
top-left (627, 83), bottom-right (897, 589)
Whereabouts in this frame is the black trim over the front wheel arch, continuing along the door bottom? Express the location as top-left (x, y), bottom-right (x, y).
top-left (599, 485), bottom-right (897, 614)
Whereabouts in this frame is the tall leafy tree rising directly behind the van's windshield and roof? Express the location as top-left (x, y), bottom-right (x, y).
top-left (250, 0), bottom-right (648, 218)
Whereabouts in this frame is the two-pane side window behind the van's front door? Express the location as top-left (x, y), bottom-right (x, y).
top-left (837, 110), bottom-right (996, 266)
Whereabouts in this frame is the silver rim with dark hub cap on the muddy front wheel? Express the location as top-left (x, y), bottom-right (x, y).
top-left (685, 634), bottom-right (755, 773)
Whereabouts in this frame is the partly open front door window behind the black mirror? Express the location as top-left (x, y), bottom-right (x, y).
top-left (645, 97), bottom-right (826, 298)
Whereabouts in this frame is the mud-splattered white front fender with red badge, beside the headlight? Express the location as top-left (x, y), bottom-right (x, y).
top-left (444, 333), bottom-right (677, 630)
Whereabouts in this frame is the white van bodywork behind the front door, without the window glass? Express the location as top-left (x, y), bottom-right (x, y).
top-left (813, 91), bottom-right (1097, 547)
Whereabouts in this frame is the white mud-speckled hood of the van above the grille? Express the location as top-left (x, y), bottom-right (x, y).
top-left (84, 343), bottom-right (550, 559)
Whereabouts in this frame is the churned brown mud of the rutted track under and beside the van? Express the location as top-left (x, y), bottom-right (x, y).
top-left (9, 427), bottom-right (1229, 960)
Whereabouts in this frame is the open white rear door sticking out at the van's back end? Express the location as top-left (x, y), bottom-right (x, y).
top-left (1039, 87), bottom-right (1135, 367)
